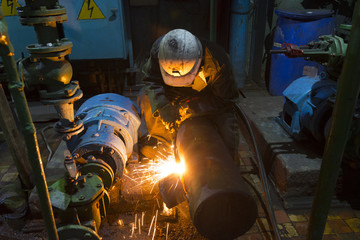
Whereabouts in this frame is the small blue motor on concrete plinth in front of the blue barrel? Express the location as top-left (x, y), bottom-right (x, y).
top-left (280, 76), bottom-right (336, 142)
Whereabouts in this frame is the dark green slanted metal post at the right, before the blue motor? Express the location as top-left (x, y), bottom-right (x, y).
top-left (307, 0), bottom-right (360, 240)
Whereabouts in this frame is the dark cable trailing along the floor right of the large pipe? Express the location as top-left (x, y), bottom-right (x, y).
top-left (234, 104), bottom-right (281, 240)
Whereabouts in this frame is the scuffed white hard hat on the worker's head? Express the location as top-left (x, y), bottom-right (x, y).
top-left (158, 29), bottom-right (202, 87)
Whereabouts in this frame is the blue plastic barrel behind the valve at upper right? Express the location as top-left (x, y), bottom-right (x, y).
top-left (269, 9), bottom-right (335, 96)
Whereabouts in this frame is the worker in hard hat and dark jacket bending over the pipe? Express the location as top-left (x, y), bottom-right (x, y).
top-left (138, 29), bottom-right (239, 161)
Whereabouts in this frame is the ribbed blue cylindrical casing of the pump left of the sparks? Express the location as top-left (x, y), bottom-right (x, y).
top-left (68, 93), bottom-right (140, 177)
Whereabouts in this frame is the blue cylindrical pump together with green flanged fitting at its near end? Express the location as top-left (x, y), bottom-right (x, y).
top-left (49, 93), bottom-right (140, 240)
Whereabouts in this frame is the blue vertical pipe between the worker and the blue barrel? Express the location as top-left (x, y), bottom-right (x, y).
top-left (229, 0), bottom-right (250, 88)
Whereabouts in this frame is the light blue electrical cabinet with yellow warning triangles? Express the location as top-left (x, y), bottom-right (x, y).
top-left (2, 0), bottom-right (129, 60)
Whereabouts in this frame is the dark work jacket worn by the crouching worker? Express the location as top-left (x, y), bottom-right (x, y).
top-left (138, 37), bottom-right (239, 143)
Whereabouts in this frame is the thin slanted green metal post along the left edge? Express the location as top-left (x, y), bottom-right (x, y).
top-left (0, 9), bottom-right (59, 240)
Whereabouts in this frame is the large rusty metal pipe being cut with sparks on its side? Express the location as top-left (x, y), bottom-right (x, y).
top-left (176, 117), bottom-right (257, 239)
